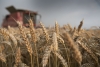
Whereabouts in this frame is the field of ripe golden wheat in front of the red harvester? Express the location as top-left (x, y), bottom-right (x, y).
top-left (0, 19), bottom-right (100, 67)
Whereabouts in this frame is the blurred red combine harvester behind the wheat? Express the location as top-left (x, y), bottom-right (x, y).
top-left (2, 6), bottom-right (41, 27)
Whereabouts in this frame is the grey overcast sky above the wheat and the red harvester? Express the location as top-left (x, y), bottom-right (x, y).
top-left (0, 0), bottom-right (100, 28)
